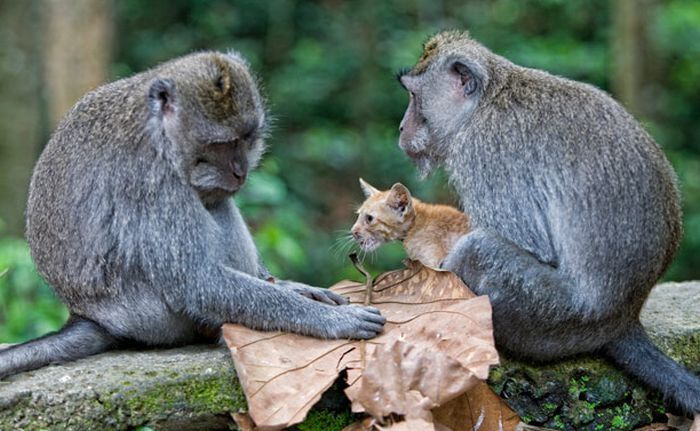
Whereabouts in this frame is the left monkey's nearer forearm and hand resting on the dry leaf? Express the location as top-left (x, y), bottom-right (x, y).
top-left (169, 265), bottom-right (385, 338)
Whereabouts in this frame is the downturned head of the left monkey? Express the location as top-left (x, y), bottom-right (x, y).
top-left (147, 52), bottom-right (267, 202)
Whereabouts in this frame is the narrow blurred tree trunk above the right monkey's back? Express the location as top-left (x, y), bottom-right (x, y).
top-left (612, 0), bottom-right (654, 118)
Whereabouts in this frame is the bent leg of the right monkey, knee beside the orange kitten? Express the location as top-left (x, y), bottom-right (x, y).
top-left (443, 230), bottom-right (620, 360)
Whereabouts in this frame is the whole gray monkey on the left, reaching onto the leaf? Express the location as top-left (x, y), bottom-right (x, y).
top-left (0, 52), bottom-right (384, 378)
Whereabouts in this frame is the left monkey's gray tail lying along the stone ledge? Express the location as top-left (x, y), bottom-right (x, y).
top-left (0, 316), bottom-right (117, 379)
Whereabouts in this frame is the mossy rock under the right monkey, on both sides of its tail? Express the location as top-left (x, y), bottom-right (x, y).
top-left (489, 282), bottom-right (700, 431)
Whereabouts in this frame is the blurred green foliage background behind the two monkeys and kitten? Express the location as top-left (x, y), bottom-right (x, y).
top-left (0, 0), bottom-right (700, 341)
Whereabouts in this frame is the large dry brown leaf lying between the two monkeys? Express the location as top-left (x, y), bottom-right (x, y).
top-left (223, 262), bottom-right (517, 431)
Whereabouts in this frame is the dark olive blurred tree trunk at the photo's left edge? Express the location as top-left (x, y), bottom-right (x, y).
top-left (0, 0), bottom-right (47, 236)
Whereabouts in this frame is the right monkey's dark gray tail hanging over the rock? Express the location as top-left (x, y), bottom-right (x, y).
top-left (605, 324), bottom-right (700, 414)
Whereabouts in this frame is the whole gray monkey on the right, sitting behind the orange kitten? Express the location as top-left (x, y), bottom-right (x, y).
top-left (399, 32), bottom-right (700, 413)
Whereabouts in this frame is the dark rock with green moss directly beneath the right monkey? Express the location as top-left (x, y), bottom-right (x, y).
top-left (489, 357), bottom-right (664, 431)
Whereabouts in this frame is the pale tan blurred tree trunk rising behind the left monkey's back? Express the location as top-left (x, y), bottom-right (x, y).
top-left (44, 0), bottom-right (114, 128)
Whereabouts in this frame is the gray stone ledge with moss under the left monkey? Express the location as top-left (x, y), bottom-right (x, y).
top-left (0, 346), bottom-right (245, 431)
